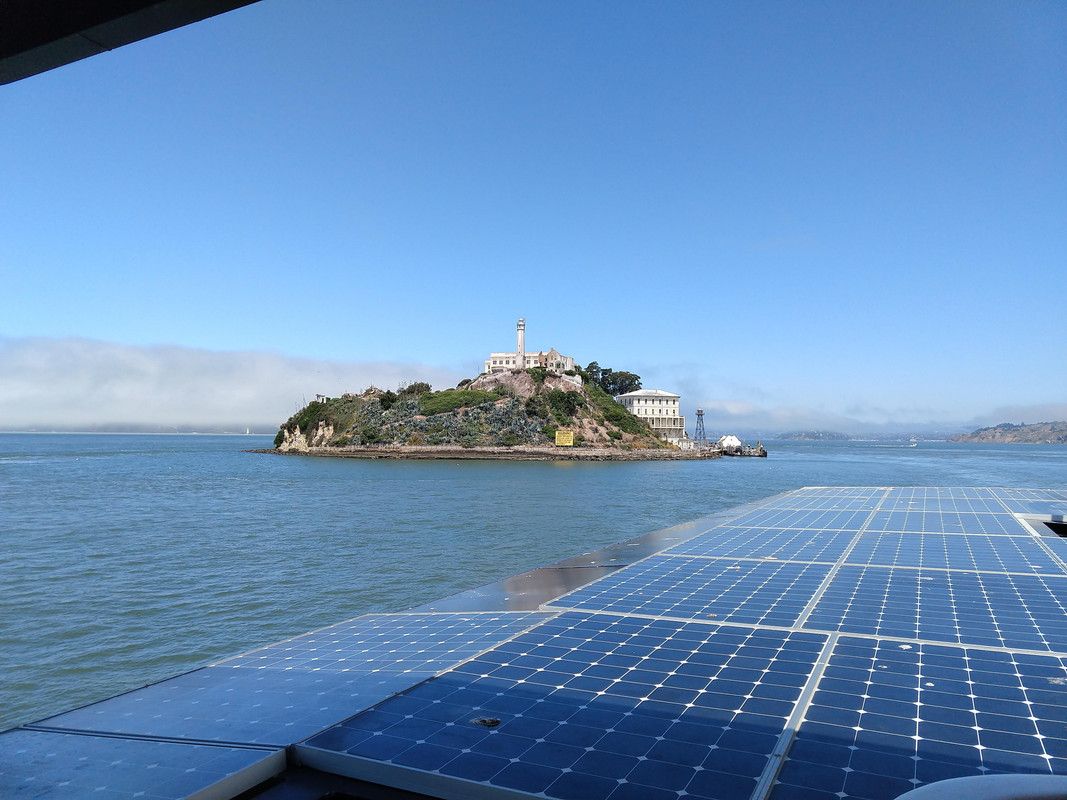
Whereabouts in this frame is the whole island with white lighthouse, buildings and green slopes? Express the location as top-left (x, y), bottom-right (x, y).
top-left (267, 319), bottom-right (738, 461)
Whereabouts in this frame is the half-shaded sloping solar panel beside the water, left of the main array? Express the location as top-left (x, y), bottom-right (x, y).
top-left (29, 613), bottom-right (544, 747)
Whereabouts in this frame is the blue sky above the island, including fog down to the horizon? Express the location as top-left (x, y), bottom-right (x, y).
top-left (0, 0), bottom-right (1067, 430)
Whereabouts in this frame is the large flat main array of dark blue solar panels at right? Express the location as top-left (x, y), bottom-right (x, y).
top-left (298, 487), bottom-right (1067, 800)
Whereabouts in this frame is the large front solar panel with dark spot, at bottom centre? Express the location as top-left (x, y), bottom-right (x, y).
top-left (307, 613), bottom-right (825, 800)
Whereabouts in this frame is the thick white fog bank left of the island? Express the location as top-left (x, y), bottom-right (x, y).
top-left (0, 338), bottom-right (464, 433)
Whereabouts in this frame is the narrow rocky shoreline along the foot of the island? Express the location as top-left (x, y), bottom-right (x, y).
top-left (249, 445), bottom-right (721, 461)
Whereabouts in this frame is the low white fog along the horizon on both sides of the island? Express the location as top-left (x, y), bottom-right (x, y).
top-left (0, 337), bottom-right (1067, 438)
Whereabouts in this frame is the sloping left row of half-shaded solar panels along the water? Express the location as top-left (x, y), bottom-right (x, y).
top-left (0, 612), bottom-right (547, 800)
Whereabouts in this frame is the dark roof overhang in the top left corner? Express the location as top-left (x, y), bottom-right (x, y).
top-left (0, 0), bottom-right (263, 84)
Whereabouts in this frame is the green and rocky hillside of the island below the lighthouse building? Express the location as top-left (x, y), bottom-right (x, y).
top-left (274, 368), bottom-right (678, 452)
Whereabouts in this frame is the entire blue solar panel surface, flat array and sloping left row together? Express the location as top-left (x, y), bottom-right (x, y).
top-left (8, 487), bottom-right (1067, 800)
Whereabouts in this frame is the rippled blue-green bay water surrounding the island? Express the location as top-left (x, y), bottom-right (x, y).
top-left (0, 434), bottom-right (1067, 729)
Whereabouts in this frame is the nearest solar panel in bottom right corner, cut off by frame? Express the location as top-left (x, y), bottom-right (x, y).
top-left (770, 637), bottom-right (1067, 800)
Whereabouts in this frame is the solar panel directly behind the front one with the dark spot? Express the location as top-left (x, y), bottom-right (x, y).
top-left (545, 556), bottom-right (830, 626)
